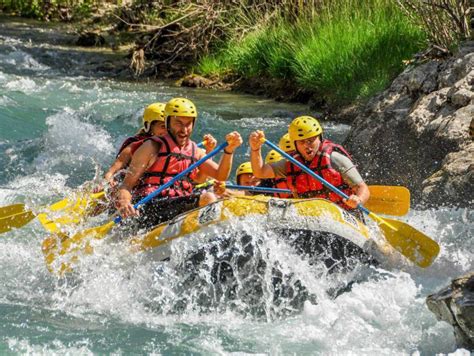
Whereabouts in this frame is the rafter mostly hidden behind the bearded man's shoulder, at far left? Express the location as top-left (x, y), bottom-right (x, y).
top-left (104, 103), bottom-right (166, 187)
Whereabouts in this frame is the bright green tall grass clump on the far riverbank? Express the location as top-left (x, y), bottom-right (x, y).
top-left (197, 0), bottom-right (426, 104)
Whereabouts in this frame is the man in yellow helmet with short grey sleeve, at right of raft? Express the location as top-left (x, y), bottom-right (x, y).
top-left (249, 116), bottom-right (370, 210)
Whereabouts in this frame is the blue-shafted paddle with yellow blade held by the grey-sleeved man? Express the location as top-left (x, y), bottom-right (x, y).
top-left (264, 140), bottom-right (439, 268)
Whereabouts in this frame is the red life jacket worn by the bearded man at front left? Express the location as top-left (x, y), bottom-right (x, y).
top-left (135, 134), bottom-right (198, 198)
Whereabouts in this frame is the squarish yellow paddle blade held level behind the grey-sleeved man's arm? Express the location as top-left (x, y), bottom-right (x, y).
top-left (365, 185), bottom-right (410, 216)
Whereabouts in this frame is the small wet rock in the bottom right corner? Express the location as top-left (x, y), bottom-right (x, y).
top-left (426, 272), bottom-right (474, 351)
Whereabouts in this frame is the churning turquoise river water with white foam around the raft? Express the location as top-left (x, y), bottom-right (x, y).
top-left (0, 18), bottom-right (474, 355)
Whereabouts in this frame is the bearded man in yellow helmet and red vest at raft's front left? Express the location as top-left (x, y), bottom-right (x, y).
top-left (116, 98), bottom-right (242, 227)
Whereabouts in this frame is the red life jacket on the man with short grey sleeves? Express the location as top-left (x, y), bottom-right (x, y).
top-left (286, 140), bottom-right (354, 210)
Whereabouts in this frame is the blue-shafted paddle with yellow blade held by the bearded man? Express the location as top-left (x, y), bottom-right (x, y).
top-left (60, 142), bottom-right (231, 243)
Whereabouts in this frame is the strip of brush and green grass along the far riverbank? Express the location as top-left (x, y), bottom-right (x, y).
top-left (0, 0), bottom-right (470, 107)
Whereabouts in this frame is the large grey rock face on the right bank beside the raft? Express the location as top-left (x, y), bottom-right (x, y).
top-left (345, 41), bottom-right (474, 206)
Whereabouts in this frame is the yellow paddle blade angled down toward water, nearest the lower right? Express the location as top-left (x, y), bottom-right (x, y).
top-left (369, 213), bottom-right (439, 268)
